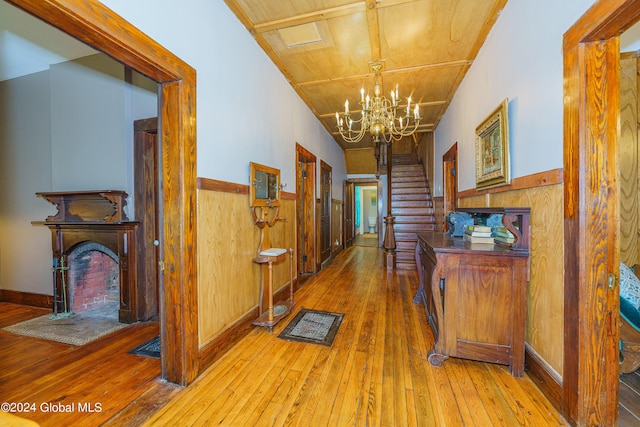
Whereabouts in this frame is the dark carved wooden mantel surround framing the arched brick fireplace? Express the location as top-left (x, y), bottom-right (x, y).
top-left (33, 190), bottom-right (143, 323)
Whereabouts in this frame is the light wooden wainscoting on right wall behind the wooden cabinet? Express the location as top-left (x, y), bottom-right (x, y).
top-left (459, 170), bottom-right (564, 404)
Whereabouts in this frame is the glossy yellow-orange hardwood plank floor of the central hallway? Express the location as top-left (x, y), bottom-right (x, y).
top-left (148, 247), bottom-right (565, 426)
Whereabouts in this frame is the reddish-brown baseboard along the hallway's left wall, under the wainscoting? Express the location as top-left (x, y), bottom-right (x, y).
top-left (199, 278), bottom-right (298, 372)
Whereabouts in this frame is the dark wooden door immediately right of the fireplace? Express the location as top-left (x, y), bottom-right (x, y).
top-left (134, 117), bottom-right (161, 320)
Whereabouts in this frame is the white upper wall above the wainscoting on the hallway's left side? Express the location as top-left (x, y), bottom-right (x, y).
top-left (102, 0), bottom-right (346, 199)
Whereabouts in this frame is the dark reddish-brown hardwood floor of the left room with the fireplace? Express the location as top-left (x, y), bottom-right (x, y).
top-left (0, 303), bottom-right (172, 426)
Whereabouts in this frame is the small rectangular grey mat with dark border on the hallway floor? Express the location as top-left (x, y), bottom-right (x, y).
top-left (278, 308), bottom-right (344, 347)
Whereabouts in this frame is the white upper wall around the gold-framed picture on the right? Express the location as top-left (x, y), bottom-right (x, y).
top-left (432, 0), bottom-right (594, 196)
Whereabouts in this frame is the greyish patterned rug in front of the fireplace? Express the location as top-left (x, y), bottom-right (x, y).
top-left (2, 304), bottom-right (129, 345)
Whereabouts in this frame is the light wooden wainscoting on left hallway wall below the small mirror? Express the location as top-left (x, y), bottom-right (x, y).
top-left (198, 178), bottom-right (296, 351)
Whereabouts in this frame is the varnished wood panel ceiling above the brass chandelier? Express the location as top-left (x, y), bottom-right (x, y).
top-left (225, 0), bottom-right (507, 154)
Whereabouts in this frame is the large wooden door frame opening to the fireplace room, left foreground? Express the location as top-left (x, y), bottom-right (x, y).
top-left (7, 0), bottom-right (199, 385)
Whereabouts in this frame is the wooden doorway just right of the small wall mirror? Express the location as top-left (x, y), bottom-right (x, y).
top-left (296, 143), bottom-right (317, 281)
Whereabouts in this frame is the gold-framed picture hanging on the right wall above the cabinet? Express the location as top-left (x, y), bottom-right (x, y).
top-left (476, 98), bottom-right (511, 188)
